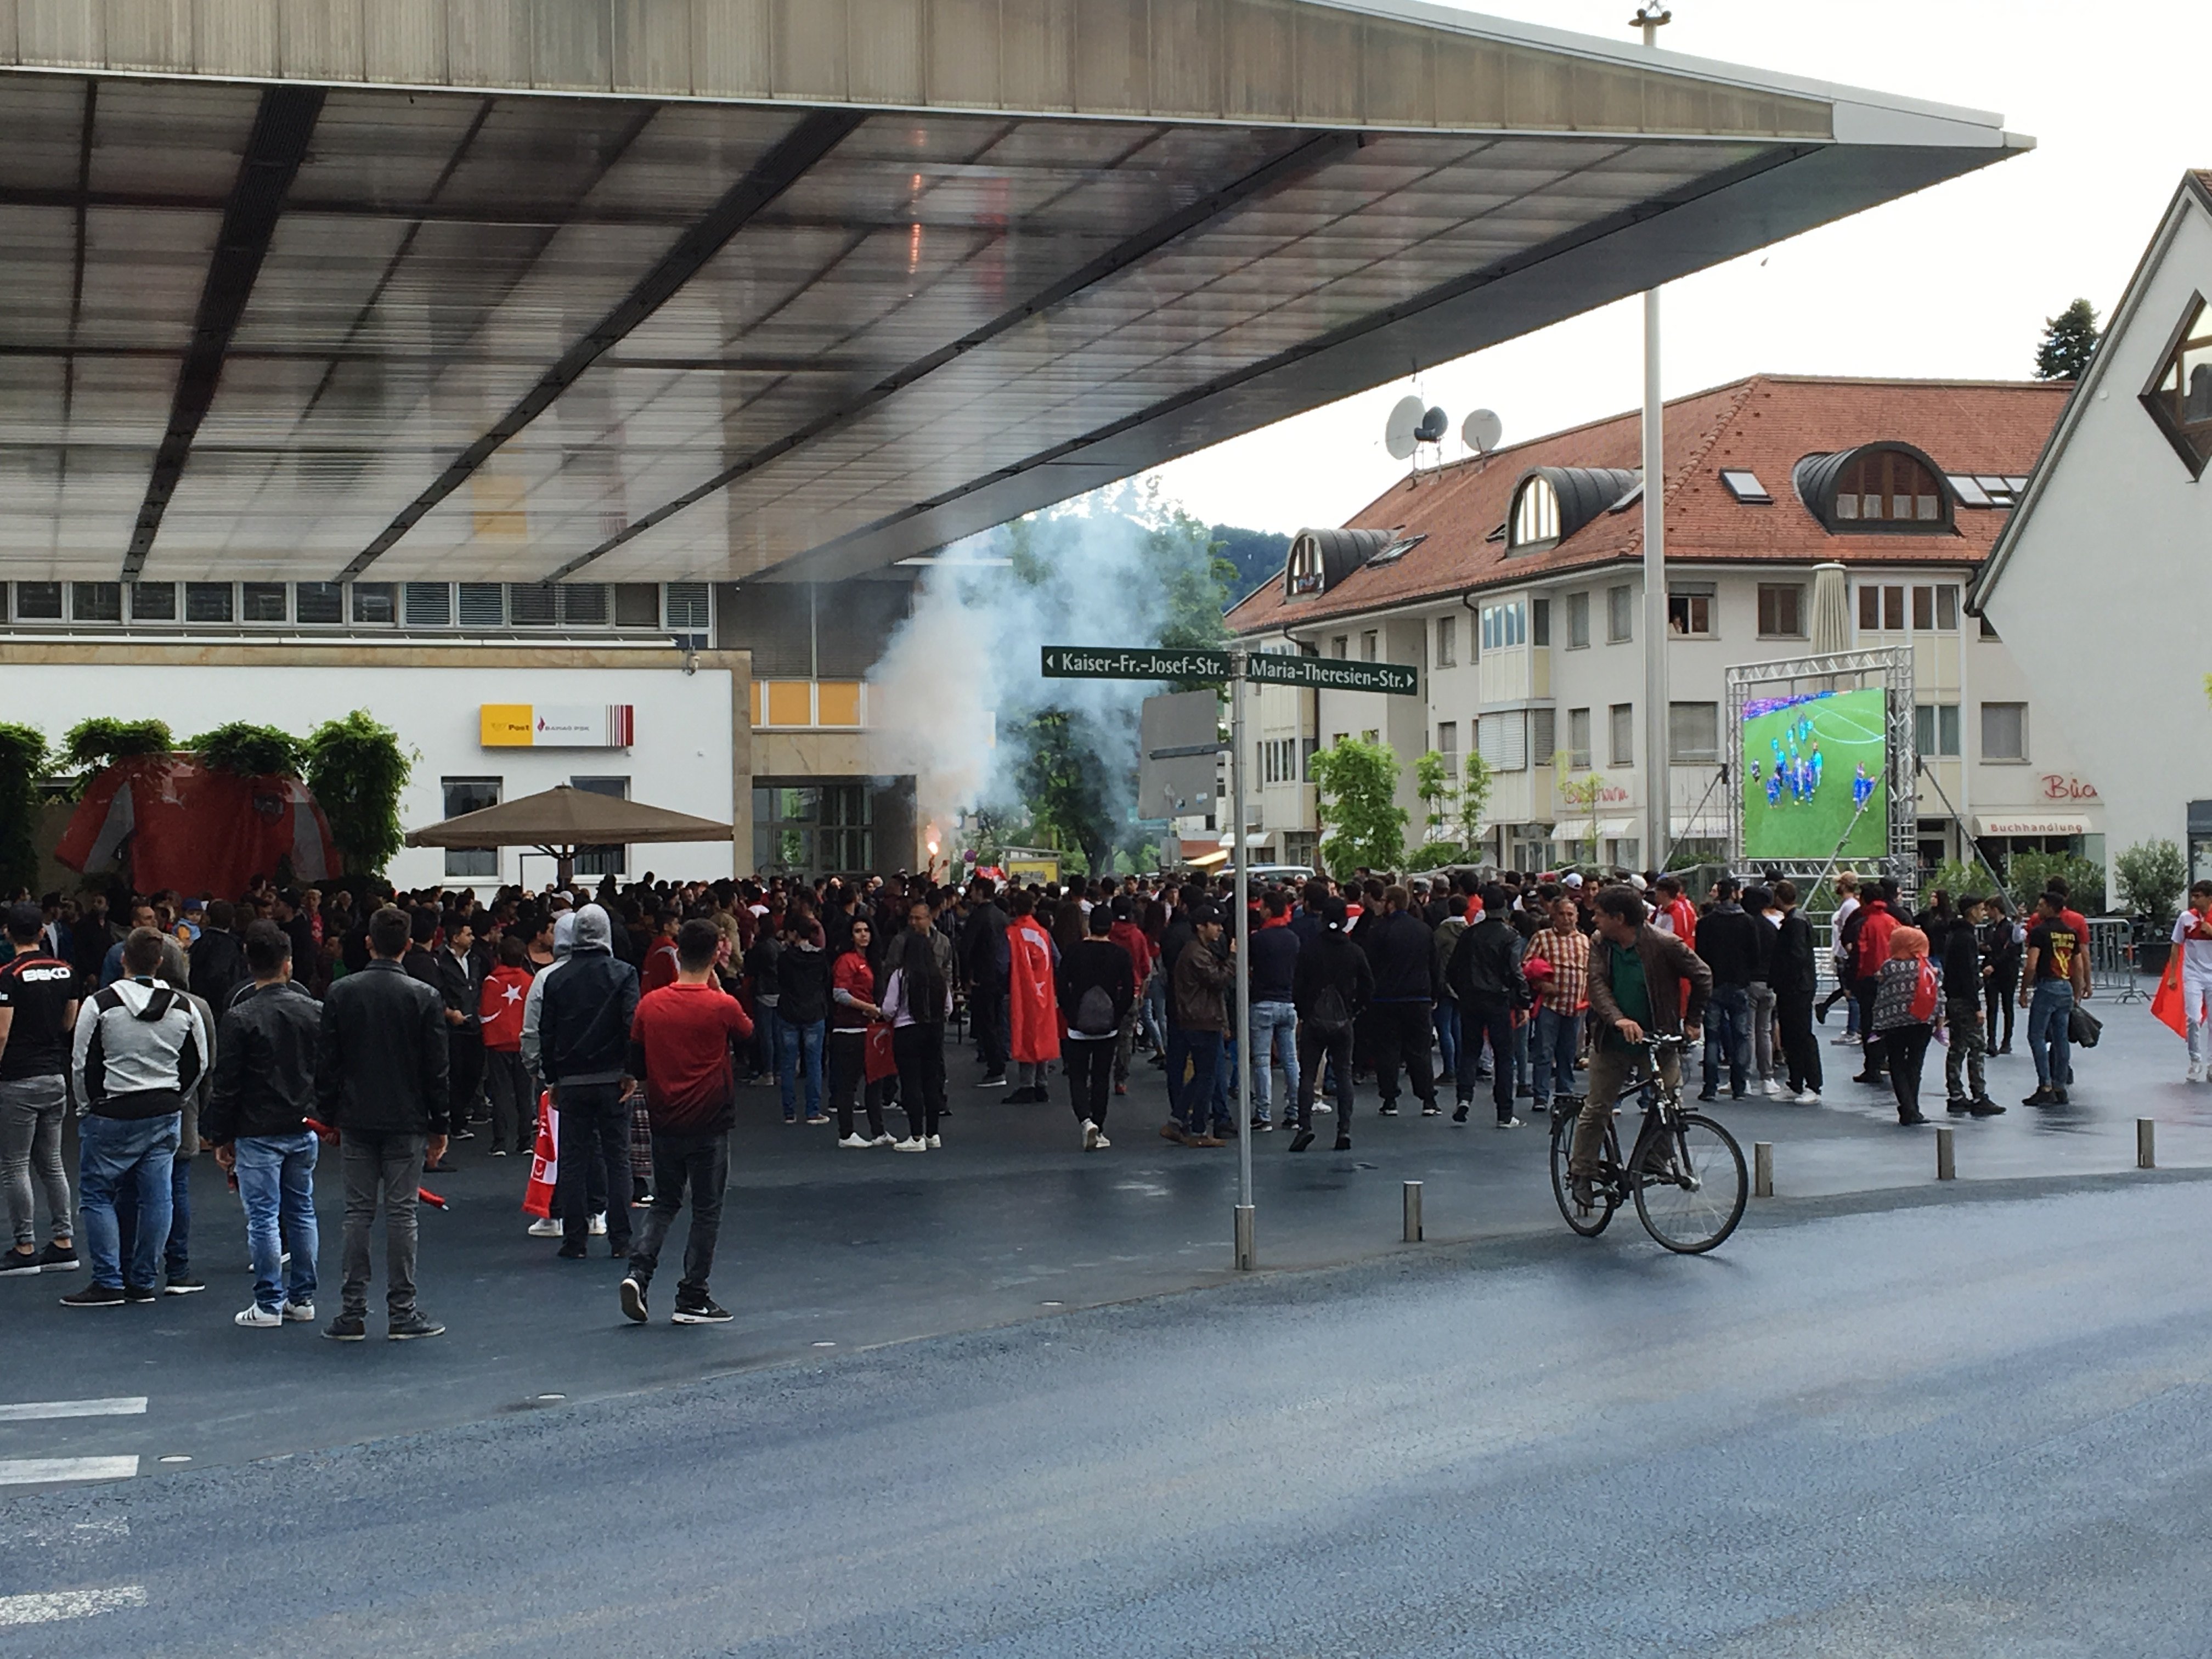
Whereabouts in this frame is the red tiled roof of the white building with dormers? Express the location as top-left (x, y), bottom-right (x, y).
top-left (1230, 374), bottom-right (2073, 633)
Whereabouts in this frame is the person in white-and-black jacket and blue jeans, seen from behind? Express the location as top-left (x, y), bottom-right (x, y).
top-left (62, 927), bottom-right (208, 1307)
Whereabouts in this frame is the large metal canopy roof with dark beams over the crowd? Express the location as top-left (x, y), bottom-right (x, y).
top-left (0, 0), bottom-right (2026, 582)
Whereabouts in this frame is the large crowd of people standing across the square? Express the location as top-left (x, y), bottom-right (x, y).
top-left (0, 872), bottom-right (2097, 1340)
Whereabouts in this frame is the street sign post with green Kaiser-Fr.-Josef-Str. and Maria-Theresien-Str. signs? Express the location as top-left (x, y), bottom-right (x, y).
top-left (1042, 646), bottom-right (1420, 1269)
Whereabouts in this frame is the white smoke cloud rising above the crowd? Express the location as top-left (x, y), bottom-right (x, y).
top-left (870, 473), bottom-right (1205, 856)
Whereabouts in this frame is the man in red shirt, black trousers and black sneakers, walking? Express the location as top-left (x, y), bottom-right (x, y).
top-left (622, 920), bottom-right (752, 1325)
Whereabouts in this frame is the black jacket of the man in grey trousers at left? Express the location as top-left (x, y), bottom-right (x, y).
top-left (314, 958), bottom-right (452, 1135)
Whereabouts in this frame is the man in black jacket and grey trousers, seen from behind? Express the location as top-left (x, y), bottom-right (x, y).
top-left (314, 905), bottom-right (452, 1342)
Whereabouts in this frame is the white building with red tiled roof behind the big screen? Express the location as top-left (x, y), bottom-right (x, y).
top-left (1232, 376), bottom-right (2103, 872)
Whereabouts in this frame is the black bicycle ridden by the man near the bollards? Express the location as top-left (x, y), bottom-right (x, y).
top-left (1550, 1033), bottom-right (1750, 1256)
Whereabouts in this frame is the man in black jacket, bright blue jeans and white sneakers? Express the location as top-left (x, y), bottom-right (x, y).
top-left (201, 922), bottom-right (323, 1329)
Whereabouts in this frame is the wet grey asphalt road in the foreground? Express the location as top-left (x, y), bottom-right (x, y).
top-left (0, 1177), bottom-right (2212, 1659)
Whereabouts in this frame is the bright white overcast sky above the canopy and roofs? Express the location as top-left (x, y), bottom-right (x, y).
top-left (1159, 0), bottom-right (2185, 531)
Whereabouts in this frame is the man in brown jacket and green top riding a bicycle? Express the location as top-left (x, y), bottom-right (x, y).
top-left (1566, 887), bottom-right (1712, 1205)
